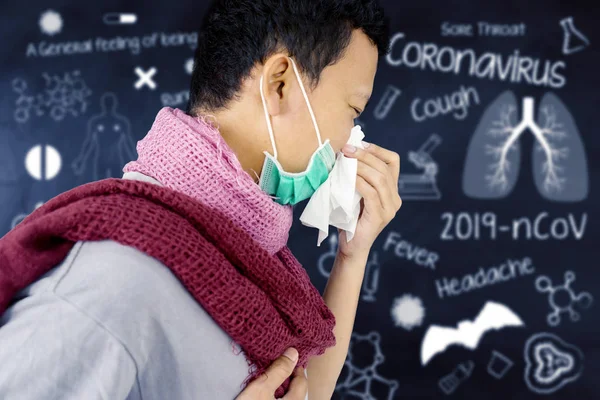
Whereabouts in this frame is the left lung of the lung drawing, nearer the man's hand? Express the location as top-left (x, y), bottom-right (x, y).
top-left (462, 90), bottom-right (523, 199)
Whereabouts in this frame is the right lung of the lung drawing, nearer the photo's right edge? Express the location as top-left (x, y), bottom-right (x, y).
top-left (531, 93), bottom-right (589, 202)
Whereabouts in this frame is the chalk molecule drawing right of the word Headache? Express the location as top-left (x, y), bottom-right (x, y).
top-left (535, 271), bottom-right (594, 326)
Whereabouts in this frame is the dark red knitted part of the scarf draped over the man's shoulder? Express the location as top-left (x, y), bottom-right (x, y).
top-left (0, 178), bottom-right (335, 397)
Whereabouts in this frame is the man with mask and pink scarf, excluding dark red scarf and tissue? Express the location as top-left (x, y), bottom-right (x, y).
top-left (0, 0), bottom-right (401, 400)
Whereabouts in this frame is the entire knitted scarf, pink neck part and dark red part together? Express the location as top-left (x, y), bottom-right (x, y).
top-left (0, 108), bottom-right (335, 397)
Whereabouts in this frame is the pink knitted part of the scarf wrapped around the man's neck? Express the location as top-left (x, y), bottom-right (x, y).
top-left (123, 107), bottom-right (293, 254)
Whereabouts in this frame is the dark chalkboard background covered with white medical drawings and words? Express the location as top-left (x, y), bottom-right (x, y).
top-left (0, 0), bottom-right (600, 400)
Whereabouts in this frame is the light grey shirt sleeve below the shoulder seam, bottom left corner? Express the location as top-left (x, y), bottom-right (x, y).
top-left (0, 262), bottom-right (138, 400)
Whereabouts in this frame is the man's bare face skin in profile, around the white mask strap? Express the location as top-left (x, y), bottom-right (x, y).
top-left (261, 30), bottom-right (378, 172)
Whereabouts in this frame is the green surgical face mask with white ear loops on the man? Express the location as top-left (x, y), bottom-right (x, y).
top-left (259, 58), bottom-right (336, 205)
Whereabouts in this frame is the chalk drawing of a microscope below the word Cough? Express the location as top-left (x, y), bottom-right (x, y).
top-left (398, 133), bottom-right (442, 200)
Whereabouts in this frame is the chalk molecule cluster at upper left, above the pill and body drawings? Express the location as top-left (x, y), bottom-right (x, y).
top-left (12, 70), bottom-right (92, 124)
